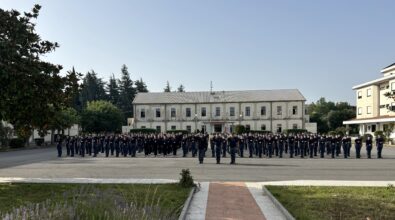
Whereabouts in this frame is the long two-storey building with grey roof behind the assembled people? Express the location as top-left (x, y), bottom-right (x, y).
top-left (131, 89), bottom-right (316, 133)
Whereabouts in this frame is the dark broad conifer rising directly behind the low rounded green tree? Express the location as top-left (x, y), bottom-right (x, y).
top-left (81, 70), bottom-right (108, 107)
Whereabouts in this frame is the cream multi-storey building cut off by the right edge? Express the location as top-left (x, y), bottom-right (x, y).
top-left (343, 63), bottom-right (395, 135)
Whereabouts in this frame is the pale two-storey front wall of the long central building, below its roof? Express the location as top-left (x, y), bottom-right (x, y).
top-left (133, 101), bottom-right (306, 133)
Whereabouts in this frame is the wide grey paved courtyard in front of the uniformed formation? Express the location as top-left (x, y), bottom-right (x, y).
top-left (0, 147), bottom-right (395, 182)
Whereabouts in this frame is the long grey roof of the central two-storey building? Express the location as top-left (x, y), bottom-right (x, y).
top-left (133, 89), bottom-right (306, 104)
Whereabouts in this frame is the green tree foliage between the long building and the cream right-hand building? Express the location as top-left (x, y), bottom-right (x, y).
top-left (308, 98), bottom-right (356, 133)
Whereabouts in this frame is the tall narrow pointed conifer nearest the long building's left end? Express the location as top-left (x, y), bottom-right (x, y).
top-left (118, 64), bottom-right (136, 118)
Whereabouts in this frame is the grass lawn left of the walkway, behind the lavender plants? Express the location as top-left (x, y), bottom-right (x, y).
top-left (0, 183), bottom-right (191, 219)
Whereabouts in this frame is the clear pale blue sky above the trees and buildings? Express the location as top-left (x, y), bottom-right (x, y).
top-left (0, 0), bottom-right (395, 104)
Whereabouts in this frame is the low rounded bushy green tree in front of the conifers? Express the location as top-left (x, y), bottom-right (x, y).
top-left (81, 101), bottom-right (123, 133)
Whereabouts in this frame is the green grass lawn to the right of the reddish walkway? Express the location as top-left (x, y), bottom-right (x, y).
top-left (266, 186), bottom-right (395, 220)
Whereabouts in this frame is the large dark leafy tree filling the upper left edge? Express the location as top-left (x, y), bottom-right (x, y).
top-left (0, 5), bottom-right (67, 140)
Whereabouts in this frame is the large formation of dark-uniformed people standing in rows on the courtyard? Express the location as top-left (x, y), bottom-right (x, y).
top-left (57, 133), bottom-right (384, 164)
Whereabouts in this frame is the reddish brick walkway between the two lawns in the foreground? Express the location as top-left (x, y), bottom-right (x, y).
top-left (206, 183), bottom-right (265, 220)
